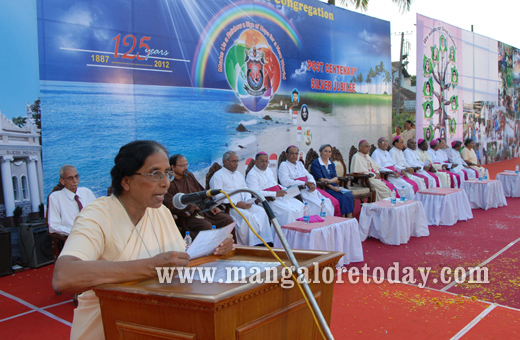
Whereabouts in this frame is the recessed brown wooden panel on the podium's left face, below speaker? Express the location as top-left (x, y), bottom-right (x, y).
top-left (116, 321), bottom-right (197, 340)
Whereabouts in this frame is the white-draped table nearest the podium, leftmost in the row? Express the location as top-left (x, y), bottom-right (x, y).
top-left (274, 216), bottom-right (363, 266)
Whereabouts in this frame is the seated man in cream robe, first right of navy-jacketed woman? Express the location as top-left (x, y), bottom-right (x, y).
top-left (350, 140), bottom-right (392, 201)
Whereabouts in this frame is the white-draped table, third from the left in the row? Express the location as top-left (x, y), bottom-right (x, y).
top-left (415, 188), bottom-right (473, 225)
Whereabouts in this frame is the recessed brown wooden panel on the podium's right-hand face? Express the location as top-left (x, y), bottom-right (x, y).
top-left (236, 292), bottom-right (321, 340)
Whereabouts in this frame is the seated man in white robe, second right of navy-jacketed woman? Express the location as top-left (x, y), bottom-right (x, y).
top-left (372, 137), bottom-right (419, 200)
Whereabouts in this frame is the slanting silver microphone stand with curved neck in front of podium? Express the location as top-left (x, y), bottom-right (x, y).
top-left (213, 188), bottom-right (334, 340)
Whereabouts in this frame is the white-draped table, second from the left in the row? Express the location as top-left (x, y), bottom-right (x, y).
top-left (359, 200), bottom-right (430, 245)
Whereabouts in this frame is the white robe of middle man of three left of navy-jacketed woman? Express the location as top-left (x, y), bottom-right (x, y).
top-left (246, 166), bottom-right (303, 226)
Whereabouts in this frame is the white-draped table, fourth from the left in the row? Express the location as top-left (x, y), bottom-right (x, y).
top-left (461, 179), bottom-right (507, 210)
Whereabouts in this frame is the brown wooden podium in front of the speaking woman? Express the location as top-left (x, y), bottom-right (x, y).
top-left (94, 247), bottom-right (343, 340)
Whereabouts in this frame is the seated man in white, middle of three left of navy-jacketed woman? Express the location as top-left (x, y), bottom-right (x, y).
top-left (246, 152), bottom-right (303, 226)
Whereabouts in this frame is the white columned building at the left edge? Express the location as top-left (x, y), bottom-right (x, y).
top-left (0, 104), bottom-right (44, 218)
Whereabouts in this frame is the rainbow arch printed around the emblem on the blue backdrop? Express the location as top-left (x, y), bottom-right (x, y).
top-left (191, 1), bottom-right (302, 87)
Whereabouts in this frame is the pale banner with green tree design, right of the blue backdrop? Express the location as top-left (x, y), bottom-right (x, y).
top-left (416, 14), bottom-right (520, 164)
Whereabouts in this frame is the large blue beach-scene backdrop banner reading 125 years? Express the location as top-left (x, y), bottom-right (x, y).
top-left (38, 0), bottom-right (391, 196)
